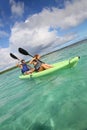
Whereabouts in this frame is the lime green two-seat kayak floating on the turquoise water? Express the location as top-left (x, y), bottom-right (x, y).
top-left (19, 56), bottom-right (80, 79)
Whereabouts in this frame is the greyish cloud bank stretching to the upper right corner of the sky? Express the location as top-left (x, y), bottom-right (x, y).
top-left (23, 0), bottom-right (87, 29)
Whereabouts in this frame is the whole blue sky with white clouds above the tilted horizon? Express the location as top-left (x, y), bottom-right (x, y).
top-left (0, 0), bottom-right (87, 71)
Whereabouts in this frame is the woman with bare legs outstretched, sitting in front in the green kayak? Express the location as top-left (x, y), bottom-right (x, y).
top-left (29, 54), bottom-right (52, 72)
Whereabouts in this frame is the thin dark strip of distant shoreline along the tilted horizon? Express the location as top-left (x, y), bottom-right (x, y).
top-left (0, 38), bottom-right (87, 74)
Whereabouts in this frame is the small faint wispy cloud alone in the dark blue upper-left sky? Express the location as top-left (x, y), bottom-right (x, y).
top-left (10, 0), bottom-right (24, 16)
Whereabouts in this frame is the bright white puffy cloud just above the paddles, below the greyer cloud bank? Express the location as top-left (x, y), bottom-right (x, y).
top-left (10, 19), bottom-right (76, 53)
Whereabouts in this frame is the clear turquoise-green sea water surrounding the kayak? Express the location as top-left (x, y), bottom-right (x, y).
top-left (0, 40), bottom-right (87, 130)
